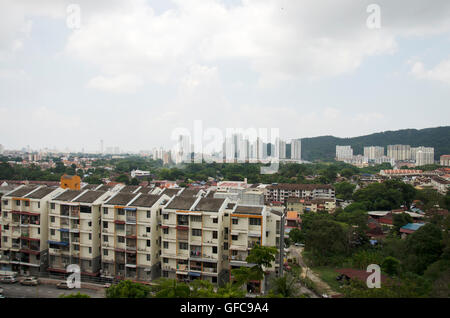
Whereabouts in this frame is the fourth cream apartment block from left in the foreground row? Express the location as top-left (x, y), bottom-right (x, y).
top-left (161, 196), bottom-right (229, 284)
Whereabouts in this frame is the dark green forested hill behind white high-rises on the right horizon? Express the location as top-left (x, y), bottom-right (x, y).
top-left (302, 126), bottom-right (450, 161)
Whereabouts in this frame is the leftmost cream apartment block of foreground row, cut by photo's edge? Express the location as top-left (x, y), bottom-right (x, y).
top-left (0, 185), bottom-right (63, 275)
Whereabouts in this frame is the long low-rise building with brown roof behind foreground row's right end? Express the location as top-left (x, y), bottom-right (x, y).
top-left (265, 183), bottom-right (335, 203)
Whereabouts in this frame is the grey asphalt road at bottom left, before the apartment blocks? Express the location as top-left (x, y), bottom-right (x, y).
top-left (0, 283), bottom-right (105, 303)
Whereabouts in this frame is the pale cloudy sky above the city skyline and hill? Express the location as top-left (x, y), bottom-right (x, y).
top-left (0, 0), bottom-right (450, 151)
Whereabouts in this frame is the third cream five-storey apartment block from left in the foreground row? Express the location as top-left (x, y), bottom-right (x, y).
top-left (101, 192), bottom-right (170, 282)
